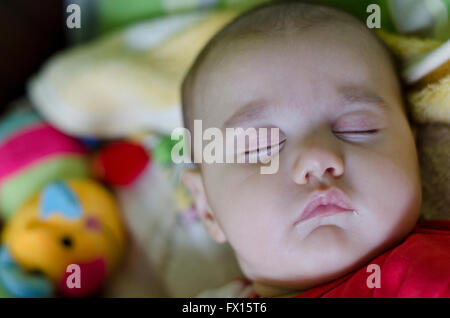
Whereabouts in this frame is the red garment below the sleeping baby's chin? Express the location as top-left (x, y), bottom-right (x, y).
top-left (251, 220), bottom-right (450, 298)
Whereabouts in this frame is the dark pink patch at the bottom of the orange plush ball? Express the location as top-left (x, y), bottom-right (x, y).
top-left (59, 258), bottom-right (106, 297)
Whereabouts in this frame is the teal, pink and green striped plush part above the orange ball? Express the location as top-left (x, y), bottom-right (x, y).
top-left (0, 102), bottom-right (89, 220)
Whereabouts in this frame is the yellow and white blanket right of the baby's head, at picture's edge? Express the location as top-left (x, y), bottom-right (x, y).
top-left (380, 33), bottom-right (450, 219)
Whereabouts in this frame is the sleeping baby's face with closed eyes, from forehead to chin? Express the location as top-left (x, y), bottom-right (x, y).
top-left (185, 24), bottom-right (421, 288)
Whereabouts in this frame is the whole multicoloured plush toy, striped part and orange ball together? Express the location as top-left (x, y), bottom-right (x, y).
top-left (0, 103), bottom-right (126, 297)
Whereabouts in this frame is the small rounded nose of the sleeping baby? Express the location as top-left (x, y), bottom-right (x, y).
top-left (292, 145), bottom-right (344, 184)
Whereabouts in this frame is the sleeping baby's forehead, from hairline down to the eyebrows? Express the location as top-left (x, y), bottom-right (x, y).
top-left (195, 26), bottom-right (395, 123)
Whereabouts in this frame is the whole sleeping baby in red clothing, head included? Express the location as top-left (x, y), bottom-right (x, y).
top-left (182, 3), bottom-right (450, 297)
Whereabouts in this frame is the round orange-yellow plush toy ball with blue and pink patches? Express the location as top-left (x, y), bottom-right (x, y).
top-left (0, 179), bottom-right (125, 296)
